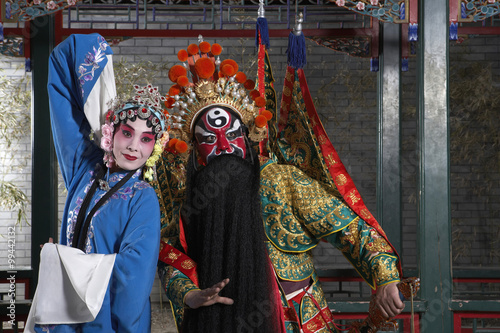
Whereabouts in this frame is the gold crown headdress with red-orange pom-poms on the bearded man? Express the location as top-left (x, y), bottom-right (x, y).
top-left (165, 38), bottom-right (272, 142)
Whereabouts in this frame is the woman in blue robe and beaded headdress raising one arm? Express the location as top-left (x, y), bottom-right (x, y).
top-left (27, 34), bottom-right (168, 333)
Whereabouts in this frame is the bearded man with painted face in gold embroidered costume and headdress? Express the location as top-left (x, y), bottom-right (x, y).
top-left (157, 40), bottom-right (404, 333)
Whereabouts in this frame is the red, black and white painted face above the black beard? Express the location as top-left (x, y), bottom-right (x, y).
top-left (194, 105), bottom-right (246, 164)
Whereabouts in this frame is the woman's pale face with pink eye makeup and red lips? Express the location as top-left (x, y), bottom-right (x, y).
top-left (113, 118), bottom-right (155, 170)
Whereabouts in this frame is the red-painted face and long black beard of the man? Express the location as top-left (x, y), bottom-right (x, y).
top-left (182, 105), bottom-right (280, 333)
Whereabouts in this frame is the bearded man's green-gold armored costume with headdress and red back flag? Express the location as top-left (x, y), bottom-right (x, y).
top-left (154, 37), bottom-right (400, 333)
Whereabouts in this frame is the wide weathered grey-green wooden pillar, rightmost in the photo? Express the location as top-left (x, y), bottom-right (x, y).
top-left (417, 0), bottom-right (453, 333)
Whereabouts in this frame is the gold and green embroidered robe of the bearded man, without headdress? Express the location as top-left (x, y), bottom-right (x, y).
top-left (160, 160), bottom-right (399, 332)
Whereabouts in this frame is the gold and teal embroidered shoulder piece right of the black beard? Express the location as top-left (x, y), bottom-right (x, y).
top-left (260, 164), bottom-right (356, 248)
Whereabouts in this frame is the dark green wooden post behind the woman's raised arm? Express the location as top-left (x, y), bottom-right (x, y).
top-left (30, 16), bottom-right (57, 295)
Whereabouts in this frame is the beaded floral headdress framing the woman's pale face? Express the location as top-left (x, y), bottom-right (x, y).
top-left (101, 85), bottom-right (171, 181)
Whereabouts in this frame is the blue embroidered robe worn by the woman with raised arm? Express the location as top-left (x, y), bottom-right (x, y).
top-left (26, 34), bottom-right (163, 333)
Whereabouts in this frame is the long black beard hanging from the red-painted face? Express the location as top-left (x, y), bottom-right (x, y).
top-left (181, 155), bottom-right (281, 333)
